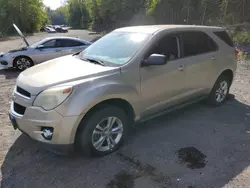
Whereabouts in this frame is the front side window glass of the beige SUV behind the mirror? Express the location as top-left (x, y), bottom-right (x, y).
top-left (146, 35), bottom-right (180, 61)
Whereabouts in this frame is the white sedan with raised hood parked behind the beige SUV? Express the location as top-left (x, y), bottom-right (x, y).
top-left (0, 23), bottom-right (91, 71)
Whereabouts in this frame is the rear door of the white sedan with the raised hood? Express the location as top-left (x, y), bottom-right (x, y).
top-left (60, 39), bottom-right (87, 56)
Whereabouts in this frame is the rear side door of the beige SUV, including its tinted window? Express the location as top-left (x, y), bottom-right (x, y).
top-left (181, 31), bottom-right (218, 100)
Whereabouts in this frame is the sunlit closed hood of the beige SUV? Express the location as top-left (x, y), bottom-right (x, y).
top-left (17, 55), bottom-right (120, 95)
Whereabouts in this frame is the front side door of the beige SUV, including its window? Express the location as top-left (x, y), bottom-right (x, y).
top-left (140, 35), bottom-right (187, 117)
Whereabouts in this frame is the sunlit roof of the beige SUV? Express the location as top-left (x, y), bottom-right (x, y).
top-left (115, 25), bottom-right (225, 34)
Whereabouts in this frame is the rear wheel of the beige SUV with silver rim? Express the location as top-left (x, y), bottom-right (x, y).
top-left (208, 75), bottom-right (230, 106)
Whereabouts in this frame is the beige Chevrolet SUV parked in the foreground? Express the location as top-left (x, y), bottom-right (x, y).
top-left (10, 25), bottom-right (236, 155)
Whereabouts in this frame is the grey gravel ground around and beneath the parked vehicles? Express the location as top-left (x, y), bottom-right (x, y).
top-left (0, 31), bottom-right (250, 188)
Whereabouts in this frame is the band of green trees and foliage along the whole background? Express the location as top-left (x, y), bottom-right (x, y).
top-left (0, 0), bottom-right (250, 40)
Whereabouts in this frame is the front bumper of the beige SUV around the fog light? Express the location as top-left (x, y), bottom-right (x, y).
top-left (10, 101), bottom-right (78, 146)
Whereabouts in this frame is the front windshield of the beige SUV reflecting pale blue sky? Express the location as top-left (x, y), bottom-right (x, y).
top-left (79, 32), bottom-right (150, 65)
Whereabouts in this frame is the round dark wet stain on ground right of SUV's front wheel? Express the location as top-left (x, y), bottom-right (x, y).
top-left (178, 147), bottom-right (207, 169)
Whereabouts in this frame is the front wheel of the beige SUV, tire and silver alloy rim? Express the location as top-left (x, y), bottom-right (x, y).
top-left (76, 106), bottom-right (128, 156)
